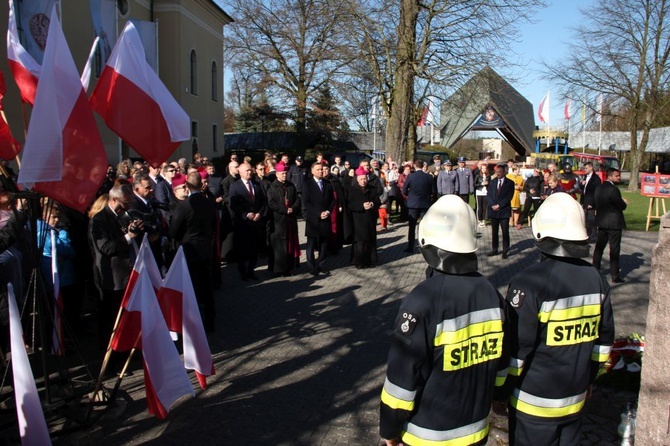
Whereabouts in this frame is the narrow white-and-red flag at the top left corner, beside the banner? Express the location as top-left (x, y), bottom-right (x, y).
top-left (7, 0), bottom-right (42, 105)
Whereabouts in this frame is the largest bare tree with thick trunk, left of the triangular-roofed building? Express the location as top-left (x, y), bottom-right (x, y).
top-left (338, 0), bottom-right (544, 159)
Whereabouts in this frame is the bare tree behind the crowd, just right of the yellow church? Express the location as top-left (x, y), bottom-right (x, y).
top-left (227, 0), bottom-right (351, 132)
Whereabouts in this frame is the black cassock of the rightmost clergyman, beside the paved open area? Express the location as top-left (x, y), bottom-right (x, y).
top-left (347, 184), bottom-right (381, 268)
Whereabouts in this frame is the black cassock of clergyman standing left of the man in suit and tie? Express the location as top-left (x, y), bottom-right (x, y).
top-left (267, 180), bottom-right (301, 274)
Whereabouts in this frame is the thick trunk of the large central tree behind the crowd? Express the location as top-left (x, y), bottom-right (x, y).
top-left (386, 0), bottom-right (419, 161)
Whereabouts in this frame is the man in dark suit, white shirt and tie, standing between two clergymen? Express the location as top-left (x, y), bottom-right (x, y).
top-left (302, 162), bottom-right (335, 276)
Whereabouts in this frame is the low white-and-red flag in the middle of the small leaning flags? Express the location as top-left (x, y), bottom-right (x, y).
top-left (126, 270), bottom-right (195, 419)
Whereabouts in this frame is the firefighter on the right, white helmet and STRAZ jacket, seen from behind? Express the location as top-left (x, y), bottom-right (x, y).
top-left (502, 194), bottom-right (614, 446)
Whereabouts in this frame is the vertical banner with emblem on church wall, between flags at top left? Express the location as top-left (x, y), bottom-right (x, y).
top-left (14, 0), bottom-right (57, 65)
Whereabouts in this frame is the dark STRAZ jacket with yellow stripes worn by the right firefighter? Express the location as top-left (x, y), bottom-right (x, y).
top-left (505, 257), bottom-right (614, 420)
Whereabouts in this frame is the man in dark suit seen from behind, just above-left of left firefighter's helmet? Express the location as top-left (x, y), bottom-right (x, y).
top-left (402, 160), bottom-right (436, 253)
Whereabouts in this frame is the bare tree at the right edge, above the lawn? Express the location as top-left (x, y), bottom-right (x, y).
top-left (545, 0), bottom-right (670, 191)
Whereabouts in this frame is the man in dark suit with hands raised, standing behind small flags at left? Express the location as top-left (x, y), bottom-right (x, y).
top-left (88, 185), bottom-right (143, 350)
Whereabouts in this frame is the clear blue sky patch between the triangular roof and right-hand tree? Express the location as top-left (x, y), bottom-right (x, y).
top-left (510, 0), bottom-right (594, 127)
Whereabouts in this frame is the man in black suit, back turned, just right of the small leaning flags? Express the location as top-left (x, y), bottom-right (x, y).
top-left (169, 172), bottom-right (216, 333)
